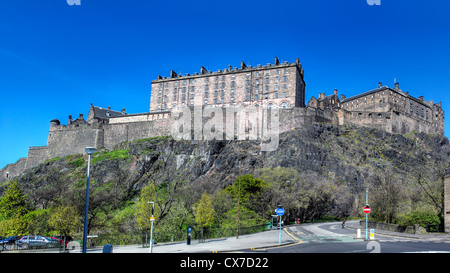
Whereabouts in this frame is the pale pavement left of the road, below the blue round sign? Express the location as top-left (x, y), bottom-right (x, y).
top-left (113, 229), bottom-right (298, 253)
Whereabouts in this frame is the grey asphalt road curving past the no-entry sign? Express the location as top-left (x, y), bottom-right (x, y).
top-left (266, 222), bottom-right (450, 253)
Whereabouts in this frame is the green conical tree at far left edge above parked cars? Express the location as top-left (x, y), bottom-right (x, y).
top-left (0, 181), bottom-right (29, 218)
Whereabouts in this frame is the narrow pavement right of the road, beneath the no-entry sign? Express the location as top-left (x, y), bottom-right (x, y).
top-left (345, 220), bottom-right (450, 241)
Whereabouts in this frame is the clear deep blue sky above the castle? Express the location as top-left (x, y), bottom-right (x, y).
top-left (0, 0), bottom-right (450, 168)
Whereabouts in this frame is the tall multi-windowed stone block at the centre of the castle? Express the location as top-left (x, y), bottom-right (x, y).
top-left (150, 57), bottom-right (305, 112)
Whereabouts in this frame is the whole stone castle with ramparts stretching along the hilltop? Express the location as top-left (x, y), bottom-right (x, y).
top-left (0, 58), bottom-right (444, 182)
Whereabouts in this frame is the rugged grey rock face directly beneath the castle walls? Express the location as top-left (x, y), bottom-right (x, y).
top-left (4, 124), bottom-right (450, 212)
